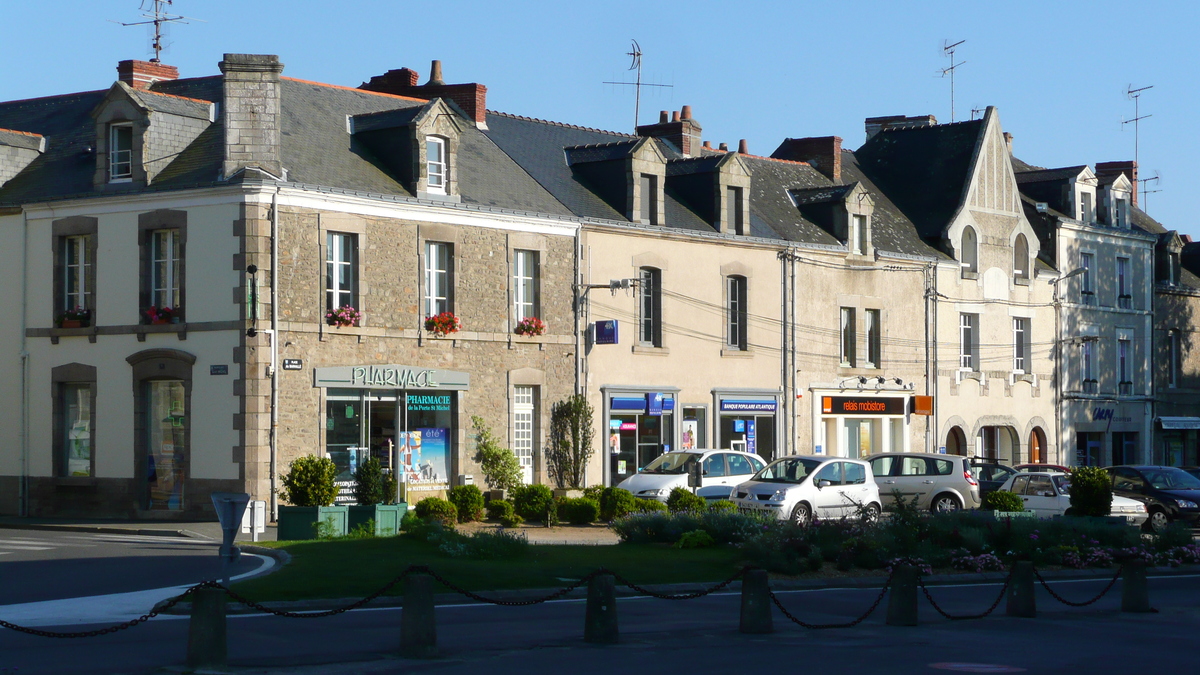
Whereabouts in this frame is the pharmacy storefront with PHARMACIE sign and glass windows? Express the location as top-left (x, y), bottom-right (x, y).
top-left (313, 365), bottom-right (470, 503)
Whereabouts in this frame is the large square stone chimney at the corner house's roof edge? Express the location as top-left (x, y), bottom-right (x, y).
top-left (217, 54), bottom-right (283, 178)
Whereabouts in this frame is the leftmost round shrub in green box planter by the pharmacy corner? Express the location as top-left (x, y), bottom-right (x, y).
top-left (278, 455), bottom-right (348, 542)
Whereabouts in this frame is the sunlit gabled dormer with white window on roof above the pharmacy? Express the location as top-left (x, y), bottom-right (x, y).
top-left (348, 98), bottom-right (467, 202)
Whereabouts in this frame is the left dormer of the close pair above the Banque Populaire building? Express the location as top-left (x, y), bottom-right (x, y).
top-left (564, 138), bottom-right (667, 225)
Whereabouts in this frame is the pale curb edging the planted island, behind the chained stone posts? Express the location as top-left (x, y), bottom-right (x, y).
top-left (163, 559), bottom-right (1200, 614)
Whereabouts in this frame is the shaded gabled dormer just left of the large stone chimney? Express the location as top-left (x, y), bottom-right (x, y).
top-left (91, 82), bottom-right (216, 190)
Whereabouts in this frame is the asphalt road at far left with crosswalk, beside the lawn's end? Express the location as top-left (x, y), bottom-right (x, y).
top-left (0, 528), bottom-right (262, 600)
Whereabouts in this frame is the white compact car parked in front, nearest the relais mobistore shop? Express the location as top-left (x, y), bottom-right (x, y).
top-left (733, 455), bottom-right (881, 525)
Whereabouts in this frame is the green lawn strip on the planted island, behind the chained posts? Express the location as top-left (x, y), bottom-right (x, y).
top-left (234, 536), bottom-right (742, 602)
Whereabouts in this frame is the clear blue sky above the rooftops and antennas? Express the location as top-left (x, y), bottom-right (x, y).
top-left (0, 0), bottom-right (1200, 238)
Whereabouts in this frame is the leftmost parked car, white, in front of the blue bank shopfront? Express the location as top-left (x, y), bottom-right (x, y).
top-left (617, 450), bottom-right (767, 502)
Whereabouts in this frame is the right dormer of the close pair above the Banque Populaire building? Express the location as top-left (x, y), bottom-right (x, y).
top-left (666, 153), bottom-right (751, 235)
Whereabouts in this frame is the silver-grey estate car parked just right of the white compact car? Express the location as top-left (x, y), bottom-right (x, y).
top-left (868, 453), bottom-right (982, 513)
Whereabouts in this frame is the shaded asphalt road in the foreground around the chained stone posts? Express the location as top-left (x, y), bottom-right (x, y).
top-left (0, 575), bottom-right (1200, 675)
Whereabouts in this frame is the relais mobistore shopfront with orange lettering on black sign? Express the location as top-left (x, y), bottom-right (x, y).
top-left (811, 389), bottom-right (911, 458)
